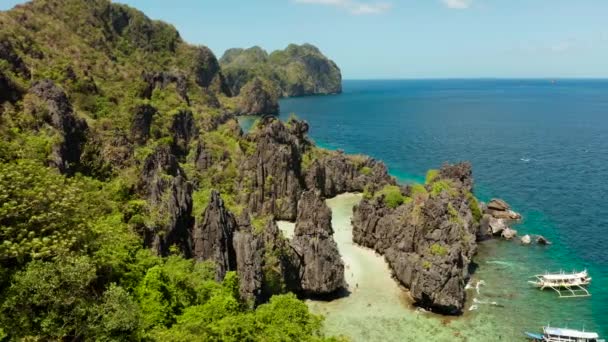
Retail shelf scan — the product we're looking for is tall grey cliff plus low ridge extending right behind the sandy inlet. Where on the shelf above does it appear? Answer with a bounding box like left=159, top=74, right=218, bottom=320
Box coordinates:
left=238, top=117, right=394, bottom=221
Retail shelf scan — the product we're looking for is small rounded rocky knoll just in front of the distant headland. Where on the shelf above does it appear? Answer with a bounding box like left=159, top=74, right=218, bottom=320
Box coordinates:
left=238, top=77, right=279, bottom=115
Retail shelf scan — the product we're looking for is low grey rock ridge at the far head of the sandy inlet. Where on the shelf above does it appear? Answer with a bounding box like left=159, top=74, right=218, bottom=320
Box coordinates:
left=306, top=152, right=395, bottom=197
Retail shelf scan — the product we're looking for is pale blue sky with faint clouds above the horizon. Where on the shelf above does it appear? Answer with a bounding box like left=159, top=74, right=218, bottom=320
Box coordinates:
left=0, top=0, right=608, bottom=79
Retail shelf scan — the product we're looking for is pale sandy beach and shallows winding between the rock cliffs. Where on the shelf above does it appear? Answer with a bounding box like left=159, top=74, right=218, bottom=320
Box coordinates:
left=278, top=194, right=518, bottom=341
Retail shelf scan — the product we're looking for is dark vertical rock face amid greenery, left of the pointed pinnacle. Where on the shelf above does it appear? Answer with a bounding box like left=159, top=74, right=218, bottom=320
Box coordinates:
left=140, top=147, right=194, bottom=257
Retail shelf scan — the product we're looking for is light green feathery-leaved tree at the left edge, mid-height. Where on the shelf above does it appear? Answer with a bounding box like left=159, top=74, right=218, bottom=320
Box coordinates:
left=0, top=160, right=90, bottom=263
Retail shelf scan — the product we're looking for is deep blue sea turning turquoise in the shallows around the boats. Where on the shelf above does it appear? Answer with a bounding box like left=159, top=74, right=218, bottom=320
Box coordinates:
left=280, top=80, right=608, bottom=338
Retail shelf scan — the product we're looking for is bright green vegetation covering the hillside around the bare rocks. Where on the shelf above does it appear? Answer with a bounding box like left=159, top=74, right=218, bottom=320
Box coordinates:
left=0, top=0, right=340, bottom=341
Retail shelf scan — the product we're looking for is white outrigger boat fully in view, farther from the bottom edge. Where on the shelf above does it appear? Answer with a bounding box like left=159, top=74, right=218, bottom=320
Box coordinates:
left=528, top=270, right=591, bottom=298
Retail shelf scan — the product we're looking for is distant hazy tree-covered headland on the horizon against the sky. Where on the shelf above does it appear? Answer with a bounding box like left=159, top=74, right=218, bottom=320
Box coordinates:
left=220, top=44, right=342, bottom=96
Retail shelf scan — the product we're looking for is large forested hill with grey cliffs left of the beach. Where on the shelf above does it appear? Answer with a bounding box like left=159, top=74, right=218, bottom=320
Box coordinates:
left=0, top=0, right=372, bottom=341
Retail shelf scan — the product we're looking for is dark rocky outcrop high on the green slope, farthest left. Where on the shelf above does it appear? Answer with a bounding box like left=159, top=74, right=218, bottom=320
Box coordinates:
left=30, top=80, right=88, bottom=174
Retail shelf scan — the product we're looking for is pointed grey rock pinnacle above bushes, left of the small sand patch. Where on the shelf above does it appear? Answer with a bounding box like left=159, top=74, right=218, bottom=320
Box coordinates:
left=192, top=190, right=236, bottom=280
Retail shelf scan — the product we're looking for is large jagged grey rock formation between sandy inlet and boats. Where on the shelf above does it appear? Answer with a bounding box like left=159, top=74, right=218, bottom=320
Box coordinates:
left=352, top=163, right=479, bottom=314
